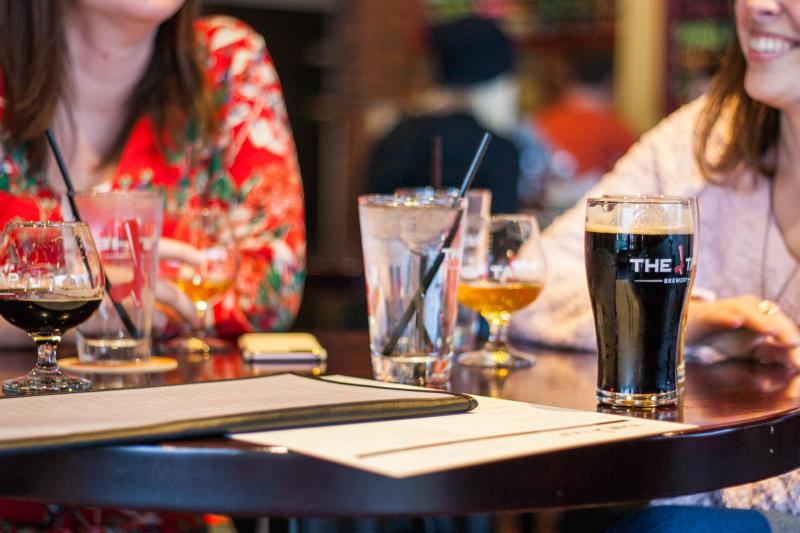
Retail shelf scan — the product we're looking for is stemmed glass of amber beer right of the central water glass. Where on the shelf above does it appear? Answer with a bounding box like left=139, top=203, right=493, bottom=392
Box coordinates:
left=458, top=214, right=546, bottom=368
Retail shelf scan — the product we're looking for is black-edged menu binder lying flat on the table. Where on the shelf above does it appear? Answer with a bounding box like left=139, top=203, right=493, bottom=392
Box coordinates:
left=0, top=374, right=477, bottom=453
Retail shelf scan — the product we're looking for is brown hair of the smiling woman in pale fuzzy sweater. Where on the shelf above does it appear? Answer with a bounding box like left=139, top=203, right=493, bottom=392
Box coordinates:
left=695, top=35, right=780, bottom=182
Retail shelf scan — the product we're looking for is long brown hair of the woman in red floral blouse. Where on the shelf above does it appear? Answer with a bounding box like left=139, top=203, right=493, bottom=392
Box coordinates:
left=0, top=0, right=215, bottom=177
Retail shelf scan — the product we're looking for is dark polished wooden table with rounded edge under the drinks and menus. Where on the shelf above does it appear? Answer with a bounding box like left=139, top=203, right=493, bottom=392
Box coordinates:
left=0, top=331, right=800, bottom=516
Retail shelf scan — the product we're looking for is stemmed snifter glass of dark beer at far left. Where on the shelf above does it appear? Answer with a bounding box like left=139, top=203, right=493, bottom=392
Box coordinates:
left=0, top=218, right=105, bottom=395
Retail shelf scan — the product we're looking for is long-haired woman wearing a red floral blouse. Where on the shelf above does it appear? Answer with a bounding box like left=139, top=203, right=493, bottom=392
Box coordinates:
left=0, top=0, right=305, bottom=344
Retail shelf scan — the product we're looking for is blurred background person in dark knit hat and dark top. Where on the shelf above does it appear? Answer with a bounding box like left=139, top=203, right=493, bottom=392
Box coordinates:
left=367, top=15, right=520, bottom=212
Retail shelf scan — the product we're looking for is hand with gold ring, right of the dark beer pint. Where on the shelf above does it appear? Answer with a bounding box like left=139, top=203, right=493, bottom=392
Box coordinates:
left=686, top=295, right=800, bottom=370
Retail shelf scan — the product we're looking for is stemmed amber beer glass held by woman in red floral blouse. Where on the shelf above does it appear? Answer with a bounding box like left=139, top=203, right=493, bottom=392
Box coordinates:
left=160, top=206, right=239, bottom=353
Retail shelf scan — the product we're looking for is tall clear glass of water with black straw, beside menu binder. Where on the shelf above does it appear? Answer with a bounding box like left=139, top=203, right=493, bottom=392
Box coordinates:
left=358, top=195, right=465, bottom=385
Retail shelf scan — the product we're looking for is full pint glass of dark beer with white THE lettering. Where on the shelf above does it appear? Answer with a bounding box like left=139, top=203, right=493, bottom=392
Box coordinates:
left=585, top=196, right=697, bottom=408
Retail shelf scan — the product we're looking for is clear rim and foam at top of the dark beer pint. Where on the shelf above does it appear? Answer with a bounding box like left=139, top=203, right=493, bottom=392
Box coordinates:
left=586, top=196, right=695, bottom=234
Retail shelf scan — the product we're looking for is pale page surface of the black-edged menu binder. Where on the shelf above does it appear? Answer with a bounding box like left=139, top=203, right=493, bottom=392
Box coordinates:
left=0, top=374, right=456, bottom=444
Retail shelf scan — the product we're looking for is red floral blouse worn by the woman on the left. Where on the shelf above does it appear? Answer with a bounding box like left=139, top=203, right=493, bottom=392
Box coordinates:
left=0, top=16, right=306, bottom=336
